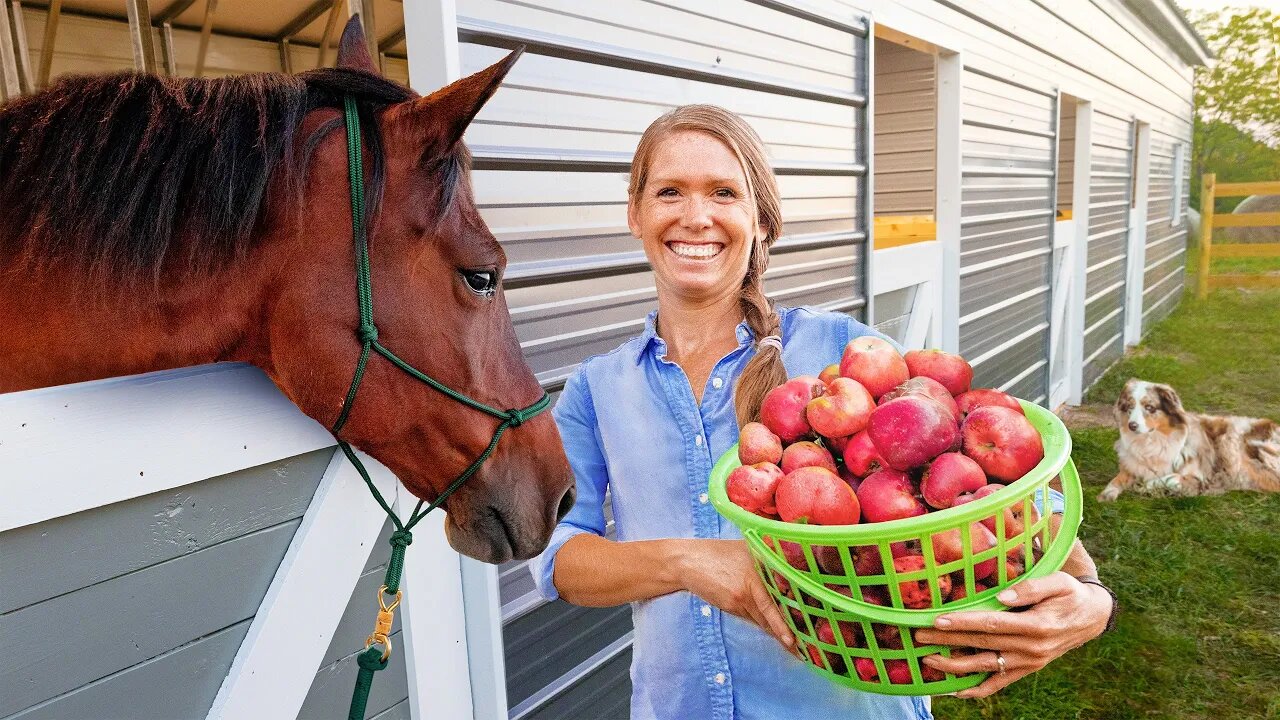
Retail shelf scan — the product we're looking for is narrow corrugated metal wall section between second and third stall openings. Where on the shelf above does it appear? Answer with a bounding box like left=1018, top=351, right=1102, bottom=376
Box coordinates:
left=1084, top=110, right=1134, bottom=387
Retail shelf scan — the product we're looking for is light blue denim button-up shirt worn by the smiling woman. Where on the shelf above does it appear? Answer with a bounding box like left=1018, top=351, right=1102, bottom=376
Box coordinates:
left=530, top=307, right=1059, bottom=720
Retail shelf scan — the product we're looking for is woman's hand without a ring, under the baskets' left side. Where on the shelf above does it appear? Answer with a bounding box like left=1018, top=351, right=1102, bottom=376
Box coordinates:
left=678, top=539, right=796, bottom=653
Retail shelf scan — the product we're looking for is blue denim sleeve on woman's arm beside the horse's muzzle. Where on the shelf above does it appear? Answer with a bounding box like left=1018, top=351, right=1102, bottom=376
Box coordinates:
left=529, top=365, right=609, bottom=600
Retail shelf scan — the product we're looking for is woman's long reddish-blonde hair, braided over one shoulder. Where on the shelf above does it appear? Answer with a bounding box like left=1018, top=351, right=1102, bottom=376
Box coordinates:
left=627, top=105, right=787, bottom=427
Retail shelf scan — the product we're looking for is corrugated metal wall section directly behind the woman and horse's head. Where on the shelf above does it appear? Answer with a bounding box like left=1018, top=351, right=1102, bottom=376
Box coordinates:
left=457, top=0, right=870, bottom=719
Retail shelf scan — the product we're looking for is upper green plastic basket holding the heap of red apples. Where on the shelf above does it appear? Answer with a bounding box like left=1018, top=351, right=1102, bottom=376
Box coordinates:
left=709, top=402, right=1083, bottom=609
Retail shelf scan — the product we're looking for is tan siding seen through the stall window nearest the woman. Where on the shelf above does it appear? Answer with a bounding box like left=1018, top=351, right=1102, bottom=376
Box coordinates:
left=874, top=37, right=938, bottom=215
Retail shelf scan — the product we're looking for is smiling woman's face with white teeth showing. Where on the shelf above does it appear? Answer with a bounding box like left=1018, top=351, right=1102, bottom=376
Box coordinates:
left=627, top=131, right=760, bottom=301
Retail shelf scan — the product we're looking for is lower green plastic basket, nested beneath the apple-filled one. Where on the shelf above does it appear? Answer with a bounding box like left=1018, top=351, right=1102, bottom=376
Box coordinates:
left=746, top=460, right=1080, bottom=696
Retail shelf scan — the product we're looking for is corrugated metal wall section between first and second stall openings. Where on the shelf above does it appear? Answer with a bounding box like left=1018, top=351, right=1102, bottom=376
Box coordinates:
left=960, top=67, right=1057, bottom=404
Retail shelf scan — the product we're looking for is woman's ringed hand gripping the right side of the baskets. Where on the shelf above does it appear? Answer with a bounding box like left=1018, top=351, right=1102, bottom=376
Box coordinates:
left=915, top=571, right=1112, bottom=698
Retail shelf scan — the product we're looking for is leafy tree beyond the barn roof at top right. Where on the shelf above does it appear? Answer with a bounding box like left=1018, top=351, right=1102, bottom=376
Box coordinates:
left=1192, top=8, right=1280, bottom=202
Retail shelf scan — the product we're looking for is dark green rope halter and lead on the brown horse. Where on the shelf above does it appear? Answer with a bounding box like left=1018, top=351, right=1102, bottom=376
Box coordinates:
left=332, top=95, right=550, bottom=720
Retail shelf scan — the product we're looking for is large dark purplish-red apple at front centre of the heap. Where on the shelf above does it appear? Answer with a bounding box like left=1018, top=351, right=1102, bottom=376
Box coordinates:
left=867, top=395, right=957, bottom=470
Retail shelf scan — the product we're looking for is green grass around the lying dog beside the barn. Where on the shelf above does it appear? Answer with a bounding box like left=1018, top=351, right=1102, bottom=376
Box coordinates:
left=933, top=272, right=1280, bottom=720
